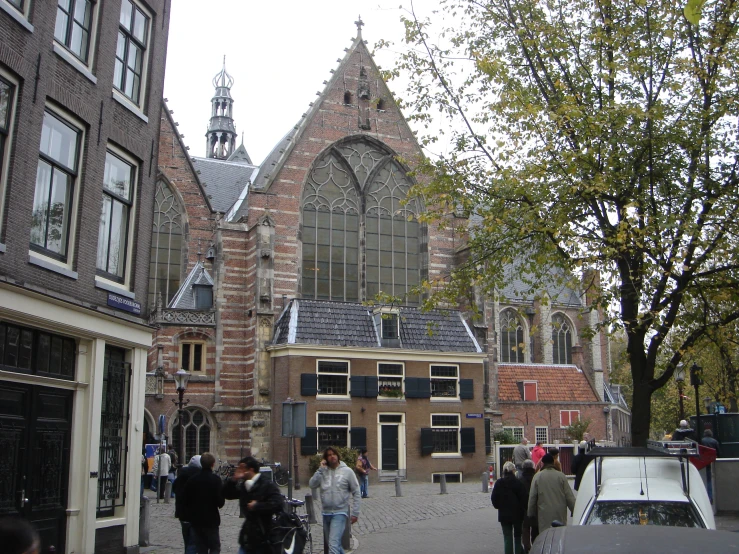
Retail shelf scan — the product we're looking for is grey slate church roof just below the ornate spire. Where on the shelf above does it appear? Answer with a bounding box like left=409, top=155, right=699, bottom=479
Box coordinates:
left=193, top=157, right=258, bottom=213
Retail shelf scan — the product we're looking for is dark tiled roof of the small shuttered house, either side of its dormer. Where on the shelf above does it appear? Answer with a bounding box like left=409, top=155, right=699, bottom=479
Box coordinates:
left=273, top=299, right=482, bottom=352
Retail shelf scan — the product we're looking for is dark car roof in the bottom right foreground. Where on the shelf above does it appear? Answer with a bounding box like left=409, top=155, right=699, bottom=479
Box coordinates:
left=530, top=525, right=739, bottom=554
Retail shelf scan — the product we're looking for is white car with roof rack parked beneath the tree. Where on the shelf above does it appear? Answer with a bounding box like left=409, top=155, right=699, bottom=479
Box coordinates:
left=572, top=442, right=716, bottom=529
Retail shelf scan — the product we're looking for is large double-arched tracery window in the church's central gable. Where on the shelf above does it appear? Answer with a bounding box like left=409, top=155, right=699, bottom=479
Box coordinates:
left=302, top=140, right=421, bottom=304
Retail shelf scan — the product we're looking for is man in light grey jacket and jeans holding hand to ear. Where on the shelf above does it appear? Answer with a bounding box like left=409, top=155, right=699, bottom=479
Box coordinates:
left=308, top=447, right=361, bottom=554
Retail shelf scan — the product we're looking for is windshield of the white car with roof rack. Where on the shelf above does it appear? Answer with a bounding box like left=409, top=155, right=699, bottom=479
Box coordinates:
left=585, top=501, right=704, bottom=527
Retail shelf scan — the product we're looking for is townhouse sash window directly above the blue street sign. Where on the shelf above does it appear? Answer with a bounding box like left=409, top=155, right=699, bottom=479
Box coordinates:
left=97, top=151, right=137, bottom=283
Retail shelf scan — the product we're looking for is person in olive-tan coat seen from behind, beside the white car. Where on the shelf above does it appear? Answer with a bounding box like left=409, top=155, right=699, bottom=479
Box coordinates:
left=528, top=454, right=575, bottom=533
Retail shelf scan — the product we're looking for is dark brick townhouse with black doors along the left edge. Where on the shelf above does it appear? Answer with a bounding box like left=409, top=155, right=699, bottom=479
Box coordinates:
left=0, top=0, right=169, bottom=554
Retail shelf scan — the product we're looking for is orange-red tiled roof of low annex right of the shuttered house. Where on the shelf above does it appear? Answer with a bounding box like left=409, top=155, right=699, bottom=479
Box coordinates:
left=498, top=363, right=601, bottom=402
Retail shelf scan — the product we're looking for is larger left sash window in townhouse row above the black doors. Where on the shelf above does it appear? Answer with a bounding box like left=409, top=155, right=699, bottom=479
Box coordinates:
left=31, top=110, right=83, bottom=262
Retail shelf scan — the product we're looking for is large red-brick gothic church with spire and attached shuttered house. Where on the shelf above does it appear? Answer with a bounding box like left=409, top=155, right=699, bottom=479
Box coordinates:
left=144, top=21, right=626, bottom=483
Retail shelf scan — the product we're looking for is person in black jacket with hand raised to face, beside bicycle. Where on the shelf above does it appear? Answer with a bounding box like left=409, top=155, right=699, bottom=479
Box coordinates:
left=223, top=456, right=284, bottom=554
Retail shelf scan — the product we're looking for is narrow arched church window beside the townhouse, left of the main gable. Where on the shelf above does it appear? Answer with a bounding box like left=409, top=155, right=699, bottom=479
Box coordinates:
left=149, top=180, right=183, bottom=306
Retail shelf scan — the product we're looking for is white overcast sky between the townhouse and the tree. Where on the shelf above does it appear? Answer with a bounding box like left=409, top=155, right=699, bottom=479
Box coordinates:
left=164, top=0, right=438, bottom=164
